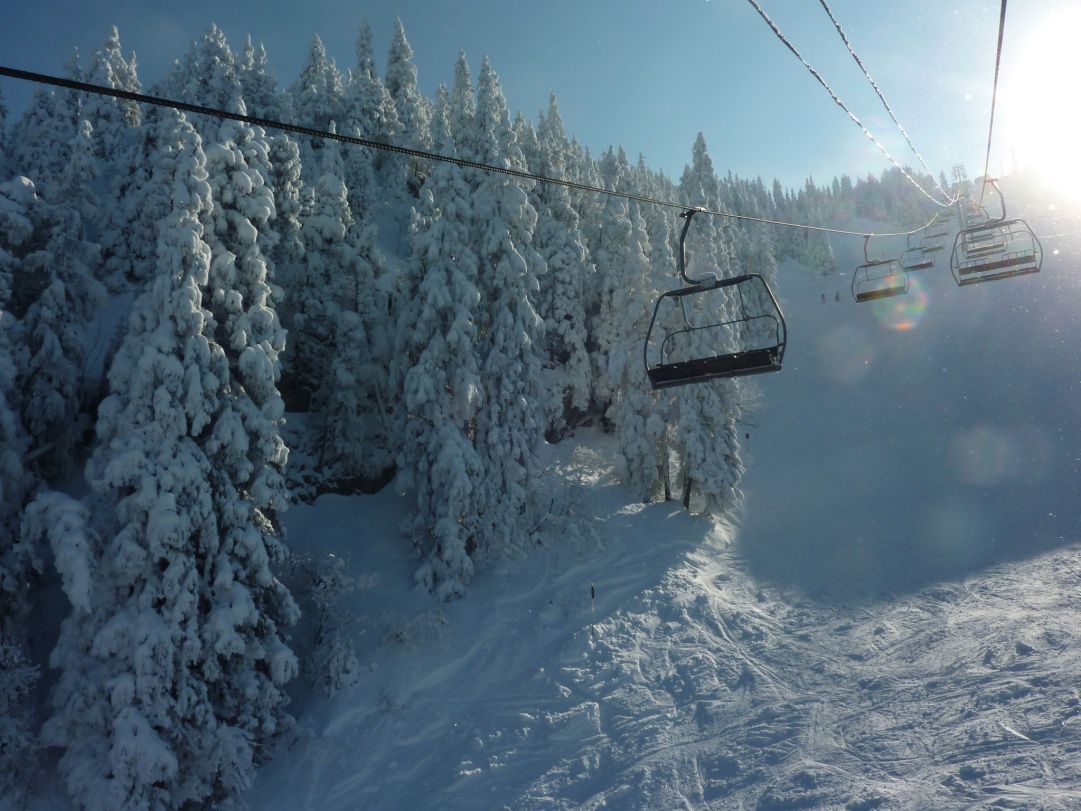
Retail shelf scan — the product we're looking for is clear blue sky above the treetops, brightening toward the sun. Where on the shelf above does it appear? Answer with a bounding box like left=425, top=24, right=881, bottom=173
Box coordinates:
left=0, top=0, right=1081, bottom=195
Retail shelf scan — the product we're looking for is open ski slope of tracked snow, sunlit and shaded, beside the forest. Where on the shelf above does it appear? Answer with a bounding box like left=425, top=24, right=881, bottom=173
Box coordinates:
left=250, top=223, right=1081, bottom=810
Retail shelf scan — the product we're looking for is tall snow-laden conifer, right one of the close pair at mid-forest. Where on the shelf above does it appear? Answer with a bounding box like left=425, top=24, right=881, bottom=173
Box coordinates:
left=472, top=58, right=545, bottom=554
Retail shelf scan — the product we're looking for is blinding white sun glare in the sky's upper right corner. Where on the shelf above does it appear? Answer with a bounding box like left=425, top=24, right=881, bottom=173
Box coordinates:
left=992, top=5, right=1081, bottom=201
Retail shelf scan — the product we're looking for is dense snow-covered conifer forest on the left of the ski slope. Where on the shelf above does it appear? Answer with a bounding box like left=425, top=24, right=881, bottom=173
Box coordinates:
left=6, top=17, right=1077, bottom=811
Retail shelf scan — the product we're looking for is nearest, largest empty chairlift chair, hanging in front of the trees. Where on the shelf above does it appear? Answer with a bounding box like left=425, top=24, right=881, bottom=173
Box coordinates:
left=643, top=209, right=788, bottom=388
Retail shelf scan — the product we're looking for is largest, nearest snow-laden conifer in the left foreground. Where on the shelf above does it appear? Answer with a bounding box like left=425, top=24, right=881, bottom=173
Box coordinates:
left=43, top=111, right=296, bottom=810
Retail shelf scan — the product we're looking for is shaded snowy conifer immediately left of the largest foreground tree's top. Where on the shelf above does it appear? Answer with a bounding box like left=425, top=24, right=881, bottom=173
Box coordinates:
left=18, top=121, right=105, bottom=479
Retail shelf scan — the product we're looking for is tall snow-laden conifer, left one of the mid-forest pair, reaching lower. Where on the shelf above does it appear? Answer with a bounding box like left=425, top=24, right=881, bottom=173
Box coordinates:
left=396, top=88, right=483, bottom=599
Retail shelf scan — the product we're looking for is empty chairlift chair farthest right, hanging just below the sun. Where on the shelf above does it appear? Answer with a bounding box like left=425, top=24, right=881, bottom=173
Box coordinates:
left=950, top=180, right=1043, bottom=287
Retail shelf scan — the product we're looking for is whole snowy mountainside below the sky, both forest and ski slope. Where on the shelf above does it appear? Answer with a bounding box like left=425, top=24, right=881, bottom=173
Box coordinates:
left=0, top=19, right=1081, bottom=811
